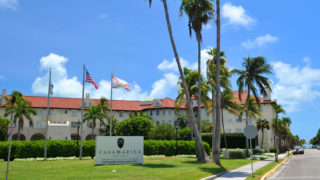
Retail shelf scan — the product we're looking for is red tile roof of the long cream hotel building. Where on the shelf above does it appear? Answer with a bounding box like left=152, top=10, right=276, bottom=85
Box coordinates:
left=0, top=91, right=275, bottom=111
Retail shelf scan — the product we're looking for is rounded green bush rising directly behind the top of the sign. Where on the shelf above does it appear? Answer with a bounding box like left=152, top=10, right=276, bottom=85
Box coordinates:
left=116, top=116, right=153, bottom=137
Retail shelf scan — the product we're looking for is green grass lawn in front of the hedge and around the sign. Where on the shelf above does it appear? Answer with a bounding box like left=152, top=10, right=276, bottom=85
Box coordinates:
left=0, top=157, right=250, bottom=180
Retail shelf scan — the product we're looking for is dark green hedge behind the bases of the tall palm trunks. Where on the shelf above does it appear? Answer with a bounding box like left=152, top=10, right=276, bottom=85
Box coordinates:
left=202, top=133, right=256, bottom=149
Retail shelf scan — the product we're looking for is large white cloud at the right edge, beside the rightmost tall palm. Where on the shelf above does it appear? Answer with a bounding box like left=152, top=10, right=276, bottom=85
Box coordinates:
left=272, top=61, right=320, bottom=112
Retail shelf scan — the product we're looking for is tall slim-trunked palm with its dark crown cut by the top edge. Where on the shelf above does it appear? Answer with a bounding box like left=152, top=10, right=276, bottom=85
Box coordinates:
left=180, top=0, right=214, bottom=132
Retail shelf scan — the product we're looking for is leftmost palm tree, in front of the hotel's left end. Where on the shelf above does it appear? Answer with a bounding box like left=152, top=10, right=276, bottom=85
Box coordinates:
left=4, top=95, right=37, bottom=140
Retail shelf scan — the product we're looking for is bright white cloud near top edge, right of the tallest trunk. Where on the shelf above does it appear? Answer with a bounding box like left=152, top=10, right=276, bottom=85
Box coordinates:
left=222, top=2, right=255, bottom=28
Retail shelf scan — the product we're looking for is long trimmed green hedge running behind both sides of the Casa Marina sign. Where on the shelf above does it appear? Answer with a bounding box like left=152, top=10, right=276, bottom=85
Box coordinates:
left=0, top=140, right=210, bottom=160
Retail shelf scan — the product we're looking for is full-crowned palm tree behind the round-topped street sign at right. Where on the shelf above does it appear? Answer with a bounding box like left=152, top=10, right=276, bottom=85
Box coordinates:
left=232, top=56, right=271, bottom=155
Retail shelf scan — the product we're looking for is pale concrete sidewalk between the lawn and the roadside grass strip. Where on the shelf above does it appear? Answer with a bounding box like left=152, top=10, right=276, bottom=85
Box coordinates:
left=204, top=153, right=287, bottom=180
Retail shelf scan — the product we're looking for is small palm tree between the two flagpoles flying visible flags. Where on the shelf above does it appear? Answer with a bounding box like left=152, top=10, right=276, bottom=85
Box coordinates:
left=83, top=104, right=103, bottom=139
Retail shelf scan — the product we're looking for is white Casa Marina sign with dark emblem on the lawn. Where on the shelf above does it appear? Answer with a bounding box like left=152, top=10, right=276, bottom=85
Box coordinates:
left=95, top=136, right=143, bottom=165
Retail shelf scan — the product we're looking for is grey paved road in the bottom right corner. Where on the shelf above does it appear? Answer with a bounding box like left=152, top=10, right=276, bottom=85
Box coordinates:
left=268, top=149, right=320, bottom=180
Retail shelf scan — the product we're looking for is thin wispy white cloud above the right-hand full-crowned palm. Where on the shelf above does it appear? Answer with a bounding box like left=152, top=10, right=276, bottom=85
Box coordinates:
left=241, top=34, right=278, bottom=49
